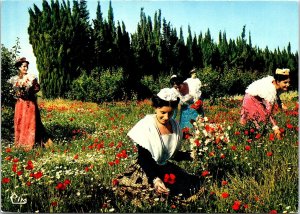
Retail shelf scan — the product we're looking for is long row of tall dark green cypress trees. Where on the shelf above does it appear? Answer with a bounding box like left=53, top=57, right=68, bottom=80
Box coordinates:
left=28, top=0, right=298, bottom=101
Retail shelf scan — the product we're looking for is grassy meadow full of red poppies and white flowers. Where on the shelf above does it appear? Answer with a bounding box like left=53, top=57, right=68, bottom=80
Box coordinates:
left=1, top=92, right=299, bottom=213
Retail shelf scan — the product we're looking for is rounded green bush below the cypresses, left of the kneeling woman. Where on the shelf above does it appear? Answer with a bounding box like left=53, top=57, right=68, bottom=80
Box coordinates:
left=68, top=69, right=125, bottom=102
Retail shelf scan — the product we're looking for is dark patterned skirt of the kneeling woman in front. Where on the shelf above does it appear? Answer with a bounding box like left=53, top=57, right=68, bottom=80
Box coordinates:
left=113, top=161, right=204, bottom=206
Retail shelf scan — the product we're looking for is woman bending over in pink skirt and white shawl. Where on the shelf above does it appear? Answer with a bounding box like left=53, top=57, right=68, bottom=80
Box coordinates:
left=240, top=69, right=290, bottom=137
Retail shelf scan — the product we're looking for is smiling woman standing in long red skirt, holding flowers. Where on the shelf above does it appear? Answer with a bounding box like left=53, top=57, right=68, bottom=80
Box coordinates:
left=8, top=57, right=52, bottom=151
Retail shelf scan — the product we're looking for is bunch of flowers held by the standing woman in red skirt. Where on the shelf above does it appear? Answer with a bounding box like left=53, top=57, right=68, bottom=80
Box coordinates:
left=7, top=74, right=36, bottom=98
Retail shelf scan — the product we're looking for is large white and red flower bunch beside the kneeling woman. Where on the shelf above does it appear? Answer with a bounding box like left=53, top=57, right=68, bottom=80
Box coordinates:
left=189, top=116, right=230, bottom=167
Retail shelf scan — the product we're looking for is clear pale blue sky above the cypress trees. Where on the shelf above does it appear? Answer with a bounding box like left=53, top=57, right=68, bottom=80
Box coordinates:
left=0, top=0, right=299, bottom=74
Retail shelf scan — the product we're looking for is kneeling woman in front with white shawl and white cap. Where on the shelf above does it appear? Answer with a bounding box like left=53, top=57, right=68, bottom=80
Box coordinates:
left=118, top=88, right=201, bottom=198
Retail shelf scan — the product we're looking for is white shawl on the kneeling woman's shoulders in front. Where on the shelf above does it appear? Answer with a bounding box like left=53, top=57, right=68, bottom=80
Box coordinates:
left=127, top=114, right=182, bottom=165
